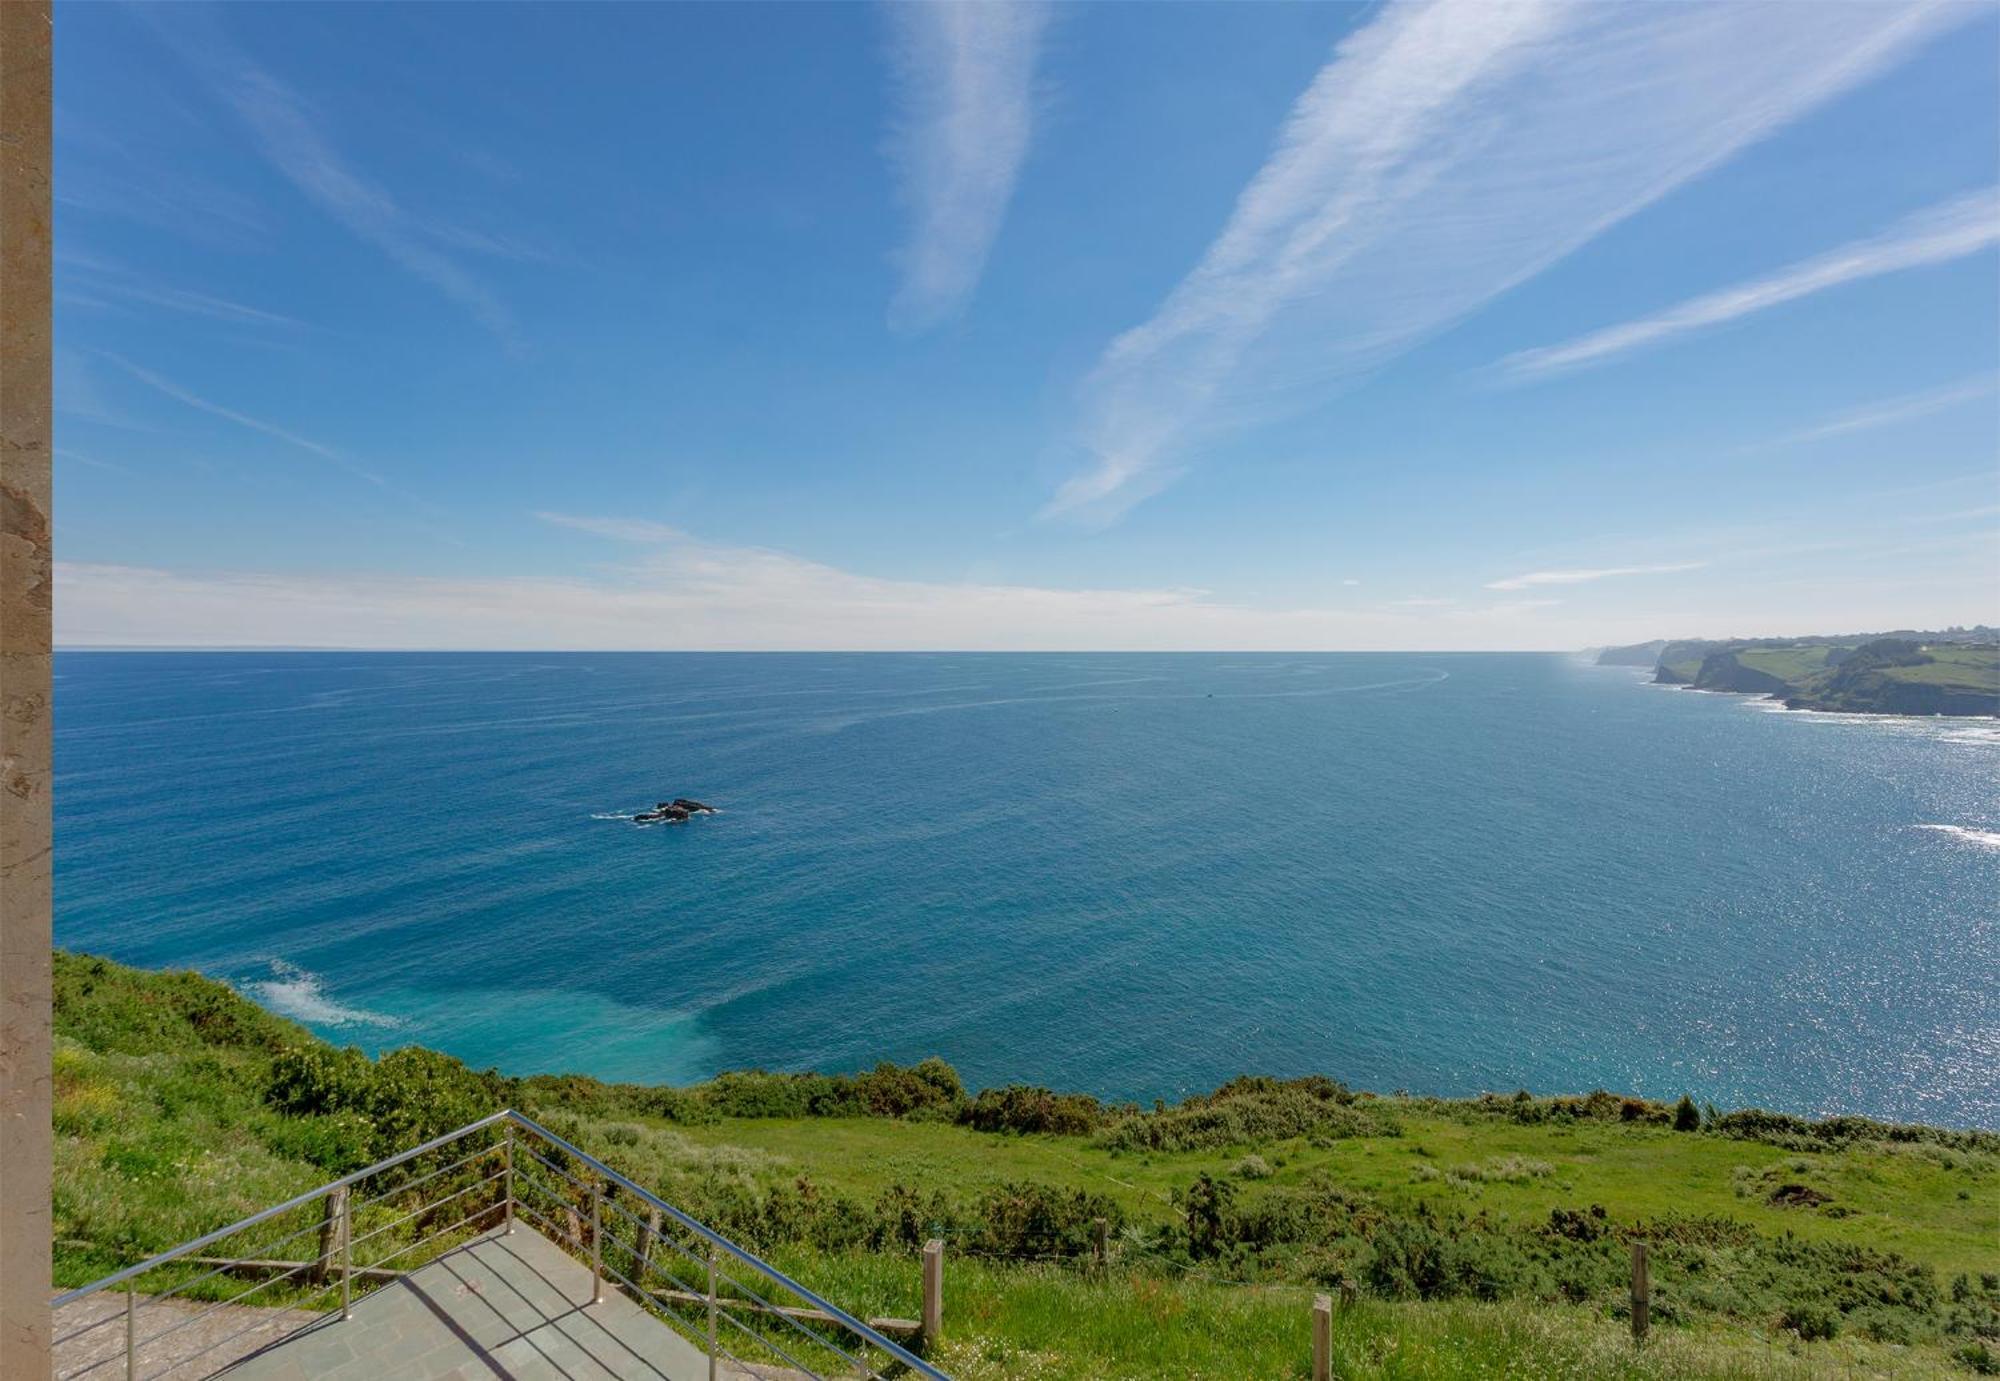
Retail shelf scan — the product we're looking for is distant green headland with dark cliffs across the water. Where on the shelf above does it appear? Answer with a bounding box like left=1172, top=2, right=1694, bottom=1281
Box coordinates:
left=1596, top=628, right=2000, bottom=715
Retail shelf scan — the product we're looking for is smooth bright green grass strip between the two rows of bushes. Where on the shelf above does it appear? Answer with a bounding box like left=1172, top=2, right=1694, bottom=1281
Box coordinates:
left=660, top=1099, right=2000, bottom=1275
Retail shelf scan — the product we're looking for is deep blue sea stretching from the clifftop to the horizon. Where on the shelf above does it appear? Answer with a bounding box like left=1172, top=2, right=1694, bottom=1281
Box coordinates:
left=56, top=652, right=2000, bottom=1127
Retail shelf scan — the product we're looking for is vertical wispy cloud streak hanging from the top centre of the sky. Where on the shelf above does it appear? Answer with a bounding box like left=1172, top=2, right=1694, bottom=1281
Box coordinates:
left=886, top=0, right=1050, bottom=330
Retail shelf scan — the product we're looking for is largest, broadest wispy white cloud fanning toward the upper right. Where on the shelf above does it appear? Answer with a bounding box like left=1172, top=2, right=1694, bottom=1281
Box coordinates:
left=1044, top=0, right=1970, bottom=516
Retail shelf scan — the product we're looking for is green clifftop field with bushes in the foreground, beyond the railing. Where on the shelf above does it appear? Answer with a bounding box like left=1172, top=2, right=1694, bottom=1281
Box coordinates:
left=54, top=953, right=2000, bottom=1379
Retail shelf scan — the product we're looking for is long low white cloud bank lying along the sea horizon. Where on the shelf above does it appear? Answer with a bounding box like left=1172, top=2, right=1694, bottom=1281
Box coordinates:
left=56, top=514, right=1588, bottom=650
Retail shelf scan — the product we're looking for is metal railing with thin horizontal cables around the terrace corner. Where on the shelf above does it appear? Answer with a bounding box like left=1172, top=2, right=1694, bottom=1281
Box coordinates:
left=52, top=1109, right=950, bottom=1381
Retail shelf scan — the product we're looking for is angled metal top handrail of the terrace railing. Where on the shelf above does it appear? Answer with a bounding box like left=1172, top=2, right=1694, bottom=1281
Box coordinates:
left=50, top=1109, right=952, bottom=1381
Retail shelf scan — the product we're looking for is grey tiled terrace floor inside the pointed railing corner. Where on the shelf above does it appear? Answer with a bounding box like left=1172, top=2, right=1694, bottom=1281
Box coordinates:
left=228, top=1225, right=712, bottom=1381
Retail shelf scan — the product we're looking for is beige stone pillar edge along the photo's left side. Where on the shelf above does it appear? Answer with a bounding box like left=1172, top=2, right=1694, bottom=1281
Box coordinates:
left=0, top=0, right=52, bottom=1381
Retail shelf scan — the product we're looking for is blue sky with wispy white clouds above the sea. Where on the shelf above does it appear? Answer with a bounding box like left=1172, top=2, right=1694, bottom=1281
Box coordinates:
left=56, top=0, right=2000, bottom=650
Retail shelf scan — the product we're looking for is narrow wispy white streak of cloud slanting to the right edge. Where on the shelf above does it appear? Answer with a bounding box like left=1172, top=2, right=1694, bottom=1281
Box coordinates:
left=1496, top=188, right=2000, bottom=382
